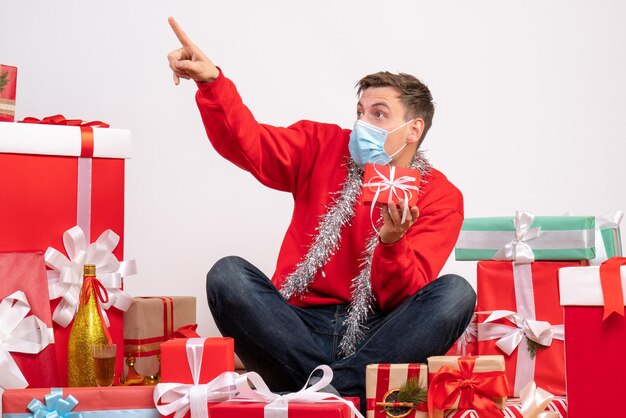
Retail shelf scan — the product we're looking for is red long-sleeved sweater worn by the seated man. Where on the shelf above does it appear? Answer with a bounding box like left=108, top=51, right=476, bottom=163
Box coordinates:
left=196, top=70, right=463, bottom=311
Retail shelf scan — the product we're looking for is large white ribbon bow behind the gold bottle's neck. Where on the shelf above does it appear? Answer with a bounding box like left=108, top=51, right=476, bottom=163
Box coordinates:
left=45, top=226, right=137, bottom=327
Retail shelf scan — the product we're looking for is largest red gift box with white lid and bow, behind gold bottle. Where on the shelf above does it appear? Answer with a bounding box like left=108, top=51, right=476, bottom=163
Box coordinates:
left=0, top=116, right=133, bottom=385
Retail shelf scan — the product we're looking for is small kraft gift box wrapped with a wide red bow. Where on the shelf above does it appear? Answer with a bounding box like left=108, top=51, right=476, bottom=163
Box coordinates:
left=428, top=356, right=509, bottom=418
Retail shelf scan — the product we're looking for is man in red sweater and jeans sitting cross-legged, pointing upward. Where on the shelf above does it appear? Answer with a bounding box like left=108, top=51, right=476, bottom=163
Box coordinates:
left=168, top=18, right=476, bottom=408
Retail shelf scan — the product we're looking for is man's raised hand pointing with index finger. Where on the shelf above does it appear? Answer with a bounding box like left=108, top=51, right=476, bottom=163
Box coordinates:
left=167, top=17, right=220, bottom=85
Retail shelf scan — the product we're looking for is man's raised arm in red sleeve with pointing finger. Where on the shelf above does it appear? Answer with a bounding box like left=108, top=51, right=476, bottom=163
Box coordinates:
left=168, top=17, right=326, bottom=193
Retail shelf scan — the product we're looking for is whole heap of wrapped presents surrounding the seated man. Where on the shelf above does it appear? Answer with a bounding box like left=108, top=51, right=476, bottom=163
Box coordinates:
left=0, top=62, right=626, bottom=418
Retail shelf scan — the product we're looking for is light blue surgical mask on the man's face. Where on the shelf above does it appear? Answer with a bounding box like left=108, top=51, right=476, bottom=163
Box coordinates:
left=348, top=119, right=415, bottom=168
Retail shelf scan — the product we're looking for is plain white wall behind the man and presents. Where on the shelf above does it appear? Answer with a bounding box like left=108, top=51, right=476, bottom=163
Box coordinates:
left=0, top=0, right=626, bottom=335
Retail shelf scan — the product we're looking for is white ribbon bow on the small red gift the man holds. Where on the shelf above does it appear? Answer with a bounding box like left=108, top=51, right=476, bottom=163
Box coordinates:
left=363, top=164, right=419, bottom=232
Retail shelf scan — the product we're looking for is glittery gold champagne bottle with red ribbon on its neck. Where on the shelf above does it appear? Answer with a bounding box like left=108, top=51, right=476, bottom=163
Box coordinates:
left=67, top=264, right=111, bottom=386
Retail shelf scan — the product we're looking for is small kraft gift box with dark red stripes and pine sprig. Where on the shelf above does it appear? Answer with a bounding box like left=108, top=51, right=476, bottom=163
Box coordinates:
left=365, top=363, right=428, bottom=418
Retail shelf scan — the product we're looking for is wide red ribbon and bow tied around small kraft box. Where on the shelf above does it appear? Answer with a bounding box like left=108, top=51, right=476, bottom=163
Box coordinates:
left=428, top=357, right=509, bottom=418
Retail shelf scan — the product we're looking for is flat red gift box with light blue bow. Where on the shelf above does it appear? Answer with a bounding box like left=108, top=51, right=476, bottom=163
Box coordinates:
left=2, top=386, right=161, bottom=418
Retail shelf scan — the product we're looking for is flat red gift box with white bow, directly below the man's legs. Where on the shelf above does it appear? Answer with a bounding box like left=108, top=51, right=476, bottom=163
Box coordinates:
left=209, top=398, right=359, bottom=418
